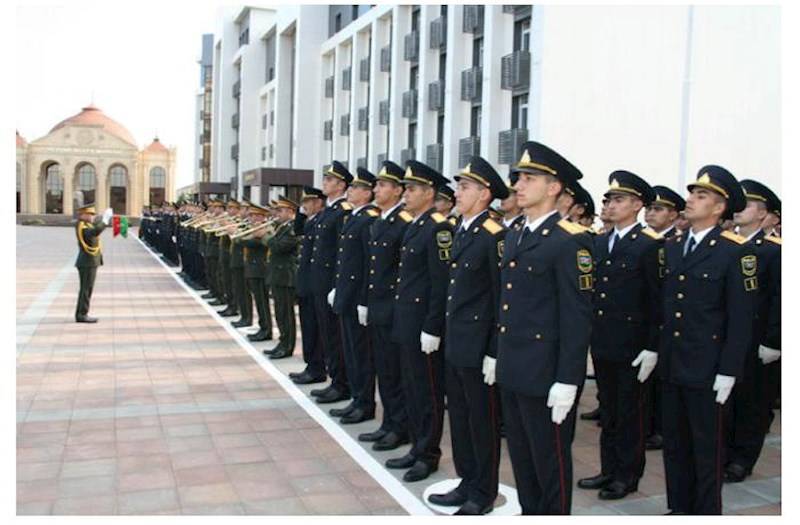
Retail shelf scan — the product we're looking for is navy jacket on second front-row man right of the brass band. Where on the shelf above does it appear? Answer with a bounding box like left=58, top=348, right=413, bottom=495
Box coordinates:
left=304, top=198, right=353, bottom=295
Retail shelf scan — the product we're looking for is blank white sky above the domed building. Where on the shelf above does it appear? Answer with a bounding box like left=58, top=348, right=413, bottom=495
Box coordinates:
left=14, top=0, right=217, bottom=189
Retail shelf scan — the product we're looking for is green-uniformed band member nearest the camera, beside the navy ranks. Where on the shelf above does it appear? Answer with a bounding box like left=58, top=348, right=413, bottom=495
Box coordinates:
left=264, top=197, right=299, bottom=359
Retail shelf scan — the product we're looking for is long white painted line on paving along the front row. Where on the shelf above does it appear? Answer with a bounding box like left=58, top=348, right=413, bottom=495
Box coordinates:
left=135, top=237, right=434, bottom=516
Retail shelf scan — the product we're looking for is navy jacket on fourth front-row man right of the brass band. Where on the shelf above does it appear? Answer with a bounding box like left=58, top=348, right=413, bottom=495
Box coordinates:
left=364, top=207, right=414, bottom=325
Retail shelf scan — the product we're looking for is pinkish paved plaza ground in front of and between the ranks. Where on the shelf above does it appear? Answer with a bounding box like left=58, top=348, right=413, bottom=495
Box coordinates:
left=16, top=226, right=781, bottom=515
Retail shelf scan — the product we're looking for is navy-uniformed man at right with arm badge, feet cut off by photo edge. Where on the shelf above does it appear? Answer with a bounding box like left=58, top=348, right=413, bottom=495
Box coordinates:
left=658, top=165, right=759, bottom=514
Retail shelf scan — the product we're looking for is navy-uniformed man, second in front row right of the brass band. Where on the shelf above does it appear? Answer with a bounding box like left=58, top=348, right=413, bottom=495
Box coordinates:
left=310, top=160, right=353, bottom=403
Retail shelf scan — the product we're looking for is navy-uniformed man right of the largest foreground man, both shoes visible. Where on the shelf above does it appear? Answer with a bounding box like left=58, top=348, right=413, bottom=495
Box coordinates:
left=578, top=170, right=664, bottom=500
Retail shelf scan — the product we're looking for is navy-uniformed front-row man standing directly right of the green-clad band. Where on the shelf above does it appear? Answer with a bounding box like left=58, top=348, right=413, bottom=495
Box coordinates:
left=289, top=186, right=327, bottom=385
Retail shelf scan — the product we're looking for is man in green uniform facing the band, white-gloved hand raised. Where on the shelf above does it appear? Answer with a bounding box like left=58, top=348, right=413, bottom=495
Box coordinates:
left=75, top=204, right=113, bottom=323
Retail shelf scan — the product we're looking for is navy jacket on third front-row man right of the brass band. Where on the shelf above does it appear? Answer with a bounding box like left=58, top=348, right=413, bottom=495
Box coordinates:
left=333, top=204, right=380, bottom=315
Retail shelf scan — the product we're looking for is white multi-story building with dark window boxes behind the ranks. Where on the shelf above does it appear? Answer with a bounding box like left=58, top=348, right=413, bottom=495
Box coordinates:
left=200, top=5, right=780, bottom=202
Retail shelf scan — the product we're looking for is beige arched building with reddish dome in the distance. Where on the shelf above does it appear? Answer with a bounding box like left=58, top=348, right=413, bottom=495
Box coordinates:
left=17, top=105, right=176, bottom=216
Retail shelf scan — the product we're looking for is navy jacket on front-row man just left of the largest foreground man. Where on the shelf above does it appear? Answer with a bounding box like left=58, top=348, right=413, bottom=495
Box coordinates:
left=445, top=211, right=506, bottom=368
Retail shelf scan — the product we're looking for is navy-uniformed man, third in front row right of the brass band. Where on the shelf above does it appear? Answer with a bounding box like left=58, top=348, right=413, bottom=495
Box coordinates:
left=330, top=170, right=380, bottom=425
